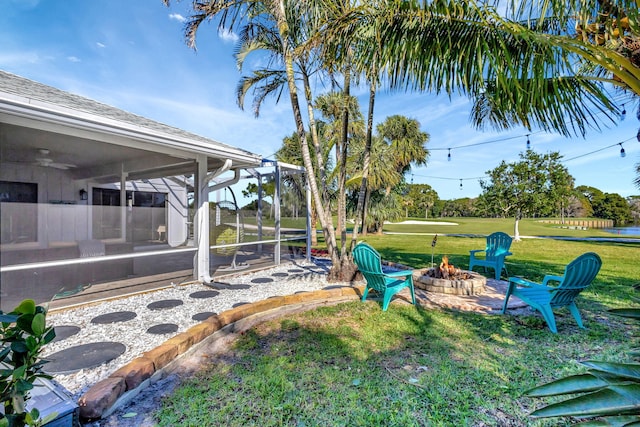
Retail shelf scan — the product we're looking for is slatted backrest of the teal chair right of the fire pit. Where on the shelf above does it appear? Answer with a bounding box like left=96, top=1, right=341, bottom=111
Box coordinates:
left=551, top=252, right=602, bottom=307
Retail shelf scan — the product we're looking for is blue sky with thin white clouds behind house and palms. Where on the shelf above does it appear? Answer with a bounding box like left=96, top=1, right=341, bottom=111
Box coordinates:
left=0, top=0, right=640, bottom=199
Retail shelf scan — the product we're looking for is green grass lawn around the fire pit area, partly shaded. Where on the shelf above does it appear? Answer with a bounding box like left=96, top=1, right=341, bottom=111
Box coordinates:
left=156, top=220, right=640, bottom=426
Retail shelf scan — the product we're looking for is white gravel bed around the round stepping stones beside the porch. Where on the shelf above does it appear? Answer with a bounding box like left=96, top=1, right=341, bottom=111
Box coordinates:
left=43, top=261, right=347, bottom=400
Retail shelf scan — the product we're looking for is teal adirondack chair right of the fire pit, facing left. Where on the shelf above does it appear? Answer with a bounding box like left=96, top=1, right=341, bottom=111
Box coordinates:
left=502, top=252, right=602, bottom=334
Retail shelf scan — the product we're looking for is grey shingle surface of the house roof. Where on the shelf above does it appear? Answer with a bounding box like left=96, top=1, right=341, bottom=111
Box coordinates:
left=0, top=70, right=259, bottom=161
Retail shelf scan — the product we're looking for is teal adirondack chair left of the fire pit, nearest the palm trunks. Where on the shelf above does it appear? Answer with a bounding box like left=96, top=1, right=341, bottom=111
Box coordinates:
left=353, top=242, right=416, bottom=311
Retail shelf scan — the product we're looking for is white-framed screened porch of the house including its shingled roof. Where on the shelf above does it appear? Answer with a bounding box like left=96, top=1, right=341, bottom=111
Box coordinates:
left=0, top=71, right=310, bottom=311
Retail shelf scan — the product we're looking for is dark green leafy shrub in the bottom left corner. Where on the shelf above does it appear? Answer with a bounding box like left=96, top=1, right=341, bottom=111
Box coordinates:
left=0, top=299, right=57, bottom=427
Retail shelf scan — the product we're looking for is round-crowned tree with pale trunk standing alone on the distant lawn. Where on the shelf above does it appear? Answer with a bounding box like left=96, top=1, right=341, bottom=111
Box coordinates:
left=480, top=150, right=573, bottom=241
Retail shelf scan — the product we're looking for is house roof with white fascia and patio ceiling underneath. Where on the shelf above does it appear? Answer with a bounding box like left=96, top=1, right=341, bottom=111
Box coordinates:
left=0, top=71, right=262, bottom=182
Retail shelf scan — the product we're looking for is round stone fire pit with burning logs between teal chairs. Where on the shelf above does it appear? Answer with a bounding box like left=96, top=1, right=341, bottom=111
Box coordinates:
left=413, top=256, right=487, bottom=295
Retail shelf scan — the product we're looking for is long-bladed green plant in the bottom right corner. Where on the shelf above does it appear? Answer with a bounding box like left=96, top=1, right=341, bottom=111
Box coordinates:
left=526, top=284, right=640, bottom=426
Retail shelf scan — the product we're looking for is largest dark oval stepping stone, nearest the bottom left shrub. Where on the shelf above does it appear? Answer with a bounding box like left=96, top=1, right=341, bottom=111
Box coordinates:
left=43, top=341, right=127, bottom=374
